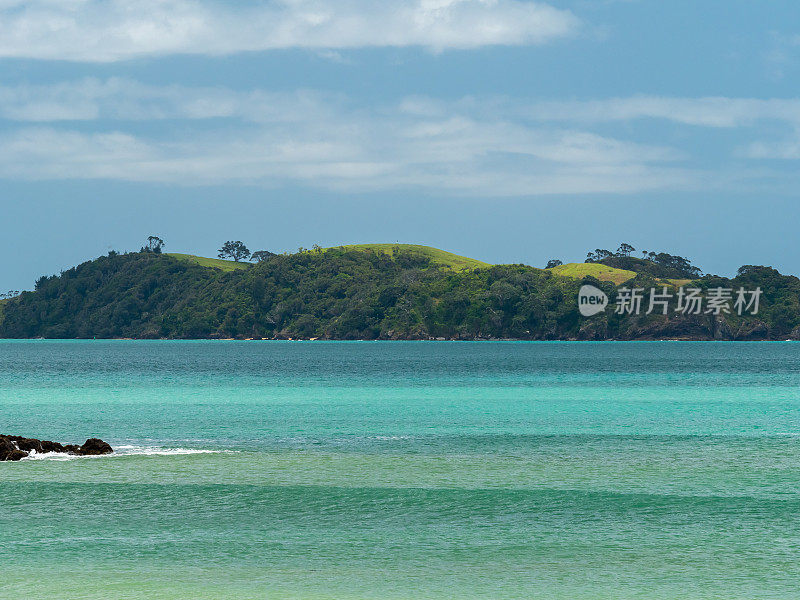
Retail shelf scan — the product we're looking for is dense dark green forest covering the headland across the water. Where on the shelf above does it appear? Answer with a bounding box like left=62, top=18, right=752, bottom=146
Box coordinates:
left=0, top=247, right=800, bottom=340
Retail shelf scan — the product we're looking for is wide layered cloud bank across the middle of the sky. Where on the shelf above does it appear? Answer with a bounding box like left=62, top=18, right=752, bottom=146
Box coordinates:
left=0, top=78, right=800, bottom=197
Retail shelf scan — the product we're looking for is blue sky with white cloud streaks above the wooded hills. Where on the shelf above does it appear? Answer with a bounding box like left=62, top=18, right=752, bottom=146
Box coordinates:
left=0, top=0, right=800, bottom=291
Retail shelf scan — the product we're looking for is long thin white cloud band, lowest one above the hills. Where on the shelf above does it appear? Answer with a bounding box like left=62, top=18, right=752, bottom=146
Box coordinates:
left=0, top=119, right=687, bottom=196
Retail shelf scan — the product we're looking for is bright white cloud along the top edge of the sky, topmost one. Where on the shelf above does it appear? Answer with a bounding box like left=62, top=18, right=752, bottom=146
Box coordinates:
left=0, top=0, right=579, bottom=62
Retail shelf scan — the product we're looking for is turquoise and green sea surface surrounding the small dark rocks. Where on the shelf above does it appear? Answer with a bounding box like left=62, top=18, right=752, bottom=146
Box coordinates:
left=0, top=341, right=800, bottom=600
